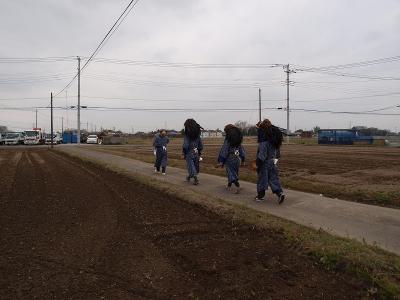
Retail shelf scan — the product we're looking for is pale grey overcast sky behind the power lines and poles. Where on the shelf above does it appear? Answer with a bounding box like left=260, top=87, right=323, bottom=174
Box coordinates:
left=0, top=0, right=400, bottom=132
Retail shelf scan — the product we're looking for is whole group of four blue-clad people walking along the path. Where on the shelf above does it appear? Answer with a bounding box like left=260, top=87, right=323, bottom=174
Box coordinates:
left=153, top=119, right=285, bottom=204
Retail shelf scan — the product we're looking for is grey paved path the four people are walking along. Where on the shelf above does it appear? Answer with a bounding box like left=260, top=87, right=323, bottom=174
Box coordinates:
left=57, top=146, right=400, bottom=254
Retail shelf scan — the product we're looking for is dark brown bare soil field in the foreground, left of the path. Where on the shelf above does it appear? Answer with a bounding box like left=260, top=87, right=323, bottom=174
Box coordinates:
left=0, top=148, right=367, bottom=299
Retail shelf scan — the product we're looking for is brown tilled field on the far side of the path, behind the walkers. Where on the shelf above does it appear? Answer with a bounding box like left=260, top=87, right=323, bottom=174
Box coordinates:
left=93, top=139, right=400, bottom=207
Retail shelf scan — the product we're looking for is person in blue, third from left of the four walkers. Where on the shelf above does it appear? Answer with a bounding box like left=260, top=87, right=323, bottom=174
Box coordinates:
left=218, top=124, right=245, bottom=194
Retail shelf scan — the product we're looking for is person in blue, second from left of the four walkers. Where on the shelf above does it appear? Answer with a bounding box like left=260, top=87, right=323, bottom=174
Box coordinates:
left=182, top=119, right=203, bottom=185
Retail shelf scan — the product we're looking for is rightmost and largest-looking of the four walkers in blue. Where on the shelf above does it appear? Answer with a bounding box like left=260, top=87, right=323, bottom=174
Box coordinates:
left=255, top=119, right=285, bottom=204
